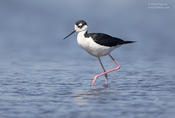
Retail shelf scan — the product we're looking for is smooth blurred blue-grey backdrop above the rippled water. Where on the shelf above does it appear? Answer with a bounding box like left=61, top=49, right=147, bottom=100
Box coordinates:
left=0, top=0, right=175, bottom=60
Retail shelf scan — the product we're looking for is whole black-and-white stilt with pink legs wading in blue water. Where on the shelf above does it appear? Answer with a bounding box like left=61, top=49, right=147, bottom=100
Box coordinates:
left=64, top=20, right=135, bottom=85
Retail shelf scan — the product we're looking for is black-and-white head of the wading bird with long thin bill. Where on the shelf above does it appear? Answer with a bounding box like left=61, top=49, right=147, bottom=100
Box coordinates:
left=64, top=20, right=88, bottom=39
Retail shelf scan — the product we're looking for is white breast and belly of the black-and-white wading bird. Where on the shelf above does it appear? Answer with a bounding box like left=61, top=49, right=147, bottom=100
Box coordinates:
left=77, top=32, right=116, bottom=57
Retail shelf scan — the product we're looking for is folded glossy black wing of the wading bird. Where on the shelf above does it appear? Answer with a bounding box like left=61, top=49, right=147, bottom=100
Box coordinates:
left=86, top=33, right=125, bottom=47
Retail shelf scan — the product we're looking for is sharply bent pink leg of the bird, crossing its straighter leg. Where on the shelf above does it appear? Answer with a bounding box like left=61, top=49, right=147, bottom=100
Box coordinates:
left=91, top=54, right=120, bottom=86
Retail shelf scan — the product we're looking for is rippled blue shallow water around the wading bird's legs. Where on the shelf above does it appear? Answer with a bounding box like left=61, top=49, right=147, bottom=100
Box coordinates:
left=0, top=53, right=175, bottom=118
